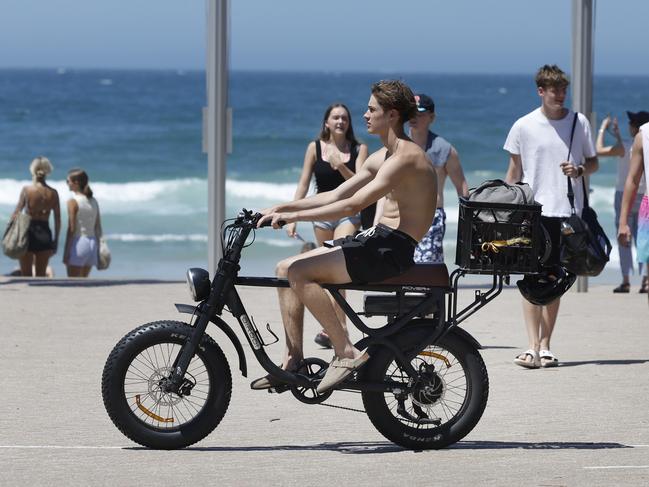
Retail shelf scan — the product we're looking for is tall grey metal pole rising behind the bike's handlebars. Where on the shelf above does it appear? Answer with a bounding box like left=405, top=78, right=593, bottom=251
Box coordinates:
left=204, top=0, right=229, bottom=273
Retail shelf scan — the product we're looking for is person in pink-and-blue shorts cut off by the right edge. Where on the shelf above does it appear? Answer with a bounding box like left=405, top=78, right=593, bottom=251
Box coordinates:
left=617, top=123, right=649, bottom=304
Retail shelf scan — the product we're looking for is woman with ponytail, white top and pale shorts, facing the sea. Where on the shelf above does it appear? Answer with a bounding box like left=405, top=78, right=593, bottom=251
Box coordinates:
left=63, top=169, right=102, bottom=277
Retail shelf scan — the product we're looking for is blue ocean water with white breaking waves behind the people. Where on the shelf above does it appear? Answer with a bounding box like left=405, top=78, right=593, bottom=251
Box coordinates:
left=0, top=69, right=649, bottom=283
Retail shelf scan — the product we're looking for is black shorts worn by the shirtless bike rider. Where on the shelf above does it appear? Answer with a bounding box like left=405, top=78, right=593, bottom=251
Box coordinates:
left=325, top=223, right=417, bottom=284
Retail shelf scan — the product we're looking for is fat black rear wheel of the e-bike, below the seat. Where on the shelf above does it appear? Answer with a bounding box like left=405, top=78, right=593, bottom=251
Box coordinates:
left=362, top=333, right=489, bottom=450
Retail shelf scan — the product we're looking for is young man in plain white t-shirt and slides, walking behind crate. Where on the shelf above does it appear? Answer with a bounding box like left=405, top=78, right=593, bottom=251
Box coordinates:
left=503, top=64, right=599, bottom=368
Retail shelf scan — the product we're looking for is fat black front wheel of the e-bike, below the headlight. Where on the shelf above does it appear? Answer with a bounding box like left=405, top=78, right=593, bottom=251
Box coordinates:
left=102, top=321, right=232, bottom=450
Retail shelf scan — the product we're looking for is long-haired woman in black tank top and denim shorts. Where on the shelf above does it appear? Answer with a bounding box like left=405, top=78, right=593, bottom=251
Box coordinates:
left=286, top=103, right=367, bottom=348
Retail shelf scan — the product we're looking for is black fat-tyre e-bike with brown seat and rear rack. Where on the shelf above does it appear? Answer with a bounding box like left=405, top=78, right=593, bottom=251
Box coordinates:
left=102, top=201, right=536, bottom=449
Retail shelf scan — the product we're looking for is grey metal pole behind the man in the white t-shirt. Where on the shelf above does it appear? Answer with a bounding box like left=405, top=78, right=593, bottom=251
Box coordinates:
left=571, top=0, right=594, bottom=292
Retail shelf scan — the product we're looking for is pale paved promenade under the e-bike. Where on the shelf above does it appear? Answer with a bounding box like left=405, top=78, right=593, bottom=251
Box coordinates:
left=0, top=278, right=649, bottom=487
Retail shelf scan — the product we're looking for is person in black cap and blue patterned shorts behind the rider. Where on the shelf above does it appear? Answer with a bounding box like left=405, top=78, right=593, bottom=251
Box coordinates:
left=410, top=93, right=469, bottom=264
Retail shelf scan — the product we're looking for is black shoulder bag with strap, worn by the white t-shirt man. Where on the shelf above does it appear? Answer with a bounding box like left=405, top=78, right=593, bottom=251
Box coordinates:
left=561, top=113, right=611, bottom=276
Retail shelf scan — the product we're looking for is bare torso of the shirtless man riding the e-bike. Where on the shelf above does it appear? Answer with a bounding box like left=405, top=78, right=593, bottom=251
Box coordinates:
left=377, top=139, right=438, bottom=241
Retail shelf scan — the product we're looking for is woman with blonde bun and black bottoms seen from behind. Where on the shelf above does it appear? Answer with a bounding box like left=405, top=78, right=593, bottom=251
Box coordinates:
left=12, top=156, right=61, bottom=277
